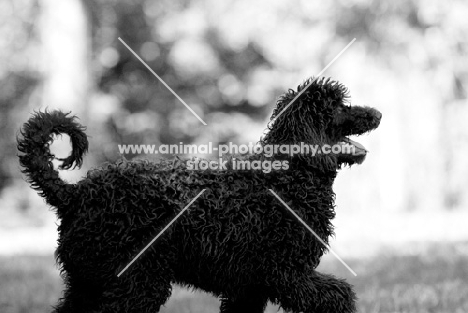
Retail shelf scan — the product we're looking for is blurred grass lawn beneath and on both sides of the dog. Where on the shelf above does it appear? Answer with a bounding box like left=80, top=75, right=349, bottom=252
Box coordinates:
left=0, top=245, right=468, bottom=313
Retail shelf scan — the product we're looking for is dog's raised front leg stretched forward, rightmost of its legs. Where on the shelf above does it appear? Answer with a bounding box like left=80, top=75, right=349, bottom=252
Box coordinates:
left=274, top=271, right=356, bottom=313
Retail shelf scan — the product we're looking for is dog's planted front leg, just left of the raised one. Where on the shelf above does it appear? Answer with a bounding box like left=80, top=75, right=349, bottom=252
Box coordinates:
left=220, top=286, right=268, bottom=313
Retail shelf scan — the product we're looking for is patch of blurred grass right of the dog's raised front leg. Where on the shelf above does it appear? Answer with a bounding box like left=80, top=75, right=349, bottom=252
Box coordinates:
left=321, top=246, right=468, bottom=313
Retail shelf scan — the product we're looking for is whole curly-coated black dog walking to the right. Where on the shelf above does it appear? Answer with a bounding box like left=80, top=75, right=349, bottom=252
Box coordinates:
left=18, top=79, right=381, bottom=313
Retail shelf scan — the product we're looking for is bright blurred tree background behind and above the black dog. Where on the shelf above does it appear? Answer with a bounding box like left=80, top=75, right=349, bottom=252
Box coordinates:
left=0, top=0, right=468, bottom=312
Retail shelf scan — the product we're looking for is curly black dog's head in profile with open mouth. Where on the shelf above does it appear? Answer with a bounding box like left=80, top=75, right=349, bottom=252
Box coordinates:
left=262, top=78, right=382, bottom=168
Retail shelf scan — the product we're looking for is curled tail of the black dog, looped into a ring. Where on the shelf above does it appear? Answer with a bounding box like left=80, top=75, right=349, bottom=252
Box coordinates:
left=17, top=111, right=88, bottom=207
